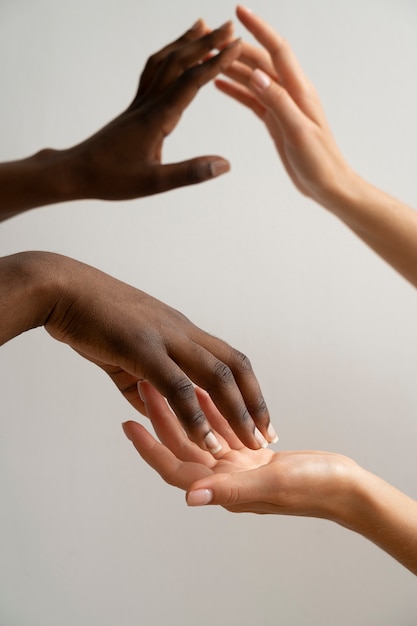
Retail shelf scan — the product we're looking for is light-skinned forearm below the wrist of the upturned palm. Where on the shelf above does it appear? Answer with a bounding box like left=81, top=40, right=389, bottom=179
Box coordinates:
left=334, top=467, right=417, bottom=574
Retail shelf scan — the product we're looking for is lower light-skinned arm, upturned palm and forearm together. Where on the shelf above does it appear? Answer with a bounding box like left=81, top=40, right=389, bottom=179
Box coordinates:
left=123, top=382, right=417, bottom=574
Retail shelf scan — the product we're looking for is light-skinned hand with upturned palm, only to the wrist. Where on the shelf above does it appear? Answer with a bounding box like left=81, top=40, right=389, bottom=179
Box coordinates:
left=123, top=383, right=359, bottom=521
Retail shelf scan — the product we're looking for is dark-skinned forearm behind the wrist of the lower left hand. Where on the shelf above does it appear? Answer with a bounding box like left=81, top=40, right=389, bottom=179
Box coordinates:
left=0, top=252, right=59, bottom=345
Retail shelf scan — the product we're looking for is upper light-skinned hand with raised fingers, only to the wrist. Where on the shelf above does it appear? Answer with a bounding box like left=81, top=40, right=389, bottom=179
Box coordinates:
left=215, top=6, right=354, bottom=208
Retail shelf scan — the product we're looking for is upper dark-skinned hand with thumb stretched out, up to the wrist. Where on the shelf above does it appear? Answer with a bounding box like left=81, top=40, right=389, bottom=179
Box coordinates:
left=69, top=20, right=240, bottom=200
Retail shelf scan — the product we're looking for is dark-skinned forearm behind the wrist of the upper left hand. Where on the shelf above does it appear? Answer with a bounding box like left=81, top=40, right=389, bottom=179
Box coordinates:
left=0, top=149, right=78, bottom=220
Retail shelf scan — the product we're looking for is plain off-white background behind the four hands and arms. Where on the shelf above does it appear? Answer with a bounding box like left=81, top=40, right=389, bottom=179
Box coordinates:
left=0, top=0, right=417, bottom=626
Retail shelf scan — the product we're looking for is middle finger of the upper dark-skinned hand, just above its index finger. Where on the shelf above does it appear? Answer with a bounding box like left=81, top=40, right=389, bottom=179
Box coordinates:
left=141, top=21, right=233, bottom=97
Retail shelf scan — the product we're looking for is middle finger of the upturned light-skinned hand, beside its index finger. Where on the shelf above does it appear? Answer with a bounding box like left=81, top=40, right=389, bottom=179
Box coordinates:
left=138, top=381, right=219, bottom=460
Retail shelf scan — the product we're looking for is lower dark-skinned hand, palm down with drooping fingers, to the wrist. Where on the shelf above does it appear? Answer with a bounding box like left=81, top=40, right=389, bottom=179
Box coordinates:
left=42, top=253, right=275, bottom=451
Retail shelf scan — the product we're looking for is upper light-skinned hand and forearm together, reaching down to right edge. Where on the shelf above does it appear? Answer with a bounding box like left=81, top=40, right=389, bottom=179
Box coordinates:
left=215, top=6, right=417, bottom=286
